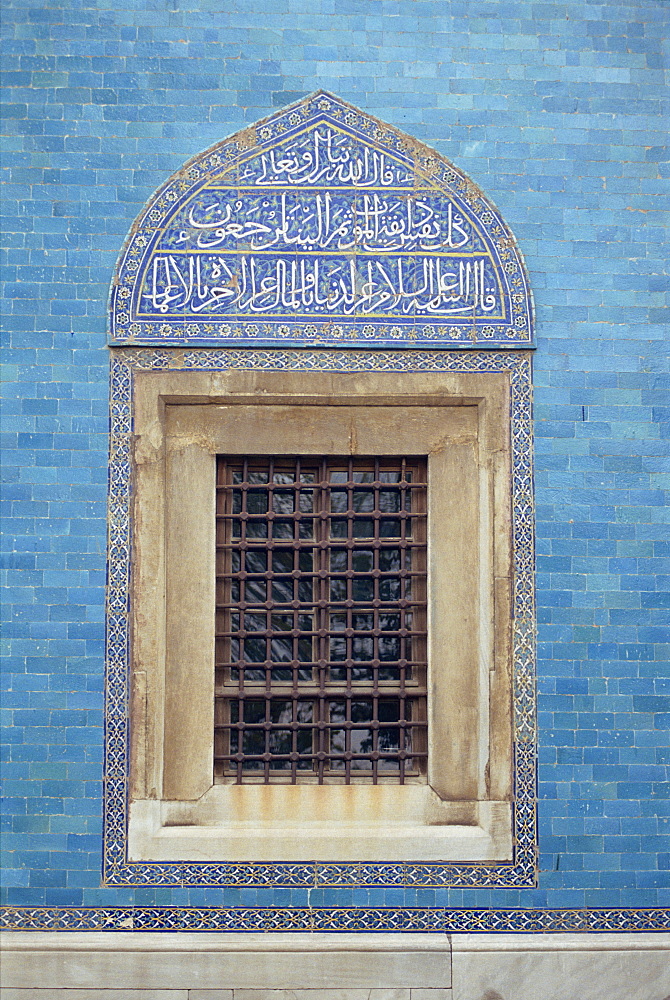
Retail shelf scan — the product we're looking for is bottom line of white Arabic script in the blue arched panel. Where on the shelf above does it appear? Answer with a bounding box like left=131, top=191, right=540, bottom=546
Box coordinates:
left=141, top=253, right=499, bottom=316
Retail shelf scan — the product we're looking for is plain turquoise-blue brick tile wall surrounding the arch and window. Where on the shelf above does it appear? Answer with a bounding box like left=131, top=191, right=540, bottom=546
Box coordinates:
left=1, top=0, right=670, bottom=908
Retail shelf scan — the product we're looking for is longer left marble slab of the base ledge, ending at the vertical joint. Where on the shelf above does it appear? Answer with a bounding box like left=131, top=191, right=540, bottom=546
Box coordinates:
left=0, top=931, right=451, bottom=1000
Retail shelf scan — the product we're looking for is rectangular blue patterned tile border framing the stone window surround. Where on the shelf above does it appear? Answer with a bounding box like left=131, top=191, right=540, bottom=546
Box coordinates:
left=103, top=348, right=537, bottom=889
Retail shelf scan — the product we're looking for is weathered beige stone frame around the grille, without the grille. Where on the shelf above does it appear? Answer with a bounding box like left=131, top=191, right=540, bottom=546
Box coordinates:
left=128, top=370, right=513, bottom=863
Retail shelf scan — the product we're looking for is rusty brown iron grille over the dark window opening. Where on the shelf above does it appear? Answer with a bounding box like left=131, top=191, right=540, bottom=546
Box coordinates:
left=214, top=456, right=427, bottom=784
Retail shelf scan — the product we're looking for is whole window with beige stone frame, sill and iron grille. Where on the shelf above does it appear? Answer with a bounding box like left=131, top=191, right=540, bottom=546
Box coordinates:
left=128, top=371, right=512, bottom=861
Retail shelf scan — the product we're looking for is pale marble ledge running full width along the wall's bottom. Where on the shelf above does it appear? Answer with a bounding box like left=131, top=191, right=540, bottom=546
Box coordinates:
left=0, top=931, right=670, bottom=1000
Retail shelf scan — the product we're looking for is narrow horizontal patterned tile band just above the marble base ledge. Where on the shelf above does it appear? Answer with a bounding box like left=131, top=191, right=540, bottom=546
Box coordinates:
left=0, top=906, right=670, bottom=934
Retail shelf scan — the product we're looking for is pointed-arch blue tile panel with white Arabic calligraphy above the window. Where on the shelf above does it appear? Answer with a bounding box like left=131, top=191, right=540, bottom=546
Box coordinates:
left=110, top=92, right=532, bottom=349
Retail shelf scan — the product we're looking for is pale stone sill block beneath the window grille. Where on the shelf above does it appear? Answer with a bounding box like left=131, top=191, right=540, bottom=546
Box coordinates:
left=129, top=792, right=511, bottom=861
